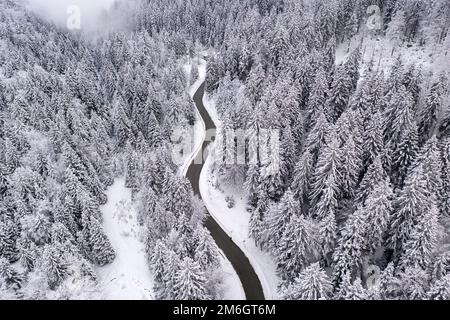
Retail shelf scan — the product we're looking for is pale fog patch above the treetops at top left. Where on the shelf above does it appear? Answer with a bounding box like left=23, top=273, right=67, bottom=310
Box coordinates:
left=26, top=0, right=118, bottom=31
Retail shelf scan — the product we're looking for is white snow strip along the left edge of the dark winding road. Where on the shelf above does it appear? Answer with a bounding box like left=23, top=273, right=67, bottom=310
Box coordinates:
left=179, top=58, right=245, bottom=300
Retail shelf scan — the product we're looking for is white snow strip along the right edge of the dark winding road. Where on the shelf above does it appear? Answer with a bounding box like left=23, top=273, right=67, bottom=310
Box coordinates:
left=200, top=94, right=280, bottom=299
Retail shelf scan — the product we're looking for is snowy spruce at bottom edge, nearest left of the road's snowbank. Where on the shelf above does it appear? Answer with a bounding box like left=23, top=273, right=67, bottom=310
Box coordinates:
left=173, top=257, right=211, bottom=300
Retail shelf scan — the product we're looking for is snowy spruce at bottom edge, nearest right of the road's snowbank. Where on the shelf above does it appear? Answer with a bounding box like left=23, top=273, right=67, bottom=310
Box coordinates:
left=283, top=262, right=333, bottom=300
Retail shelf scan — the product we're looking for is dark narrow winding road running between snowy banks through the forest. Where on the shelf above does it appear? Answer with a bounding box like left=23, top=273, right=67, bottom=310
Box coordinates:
left=186, top=83, right=264, bottom=300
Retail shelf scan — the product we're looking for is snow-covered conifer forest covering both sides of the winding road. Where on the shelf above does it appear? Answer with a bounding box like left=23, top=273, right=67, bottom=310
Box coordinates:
left=0, top=0, right=450, bottom=300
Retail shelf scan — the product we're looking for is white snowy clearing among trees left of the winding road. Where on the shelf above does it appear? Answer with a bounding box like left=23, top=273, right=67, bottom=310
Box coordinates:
left=96, top=178, right=154, bottom=300
